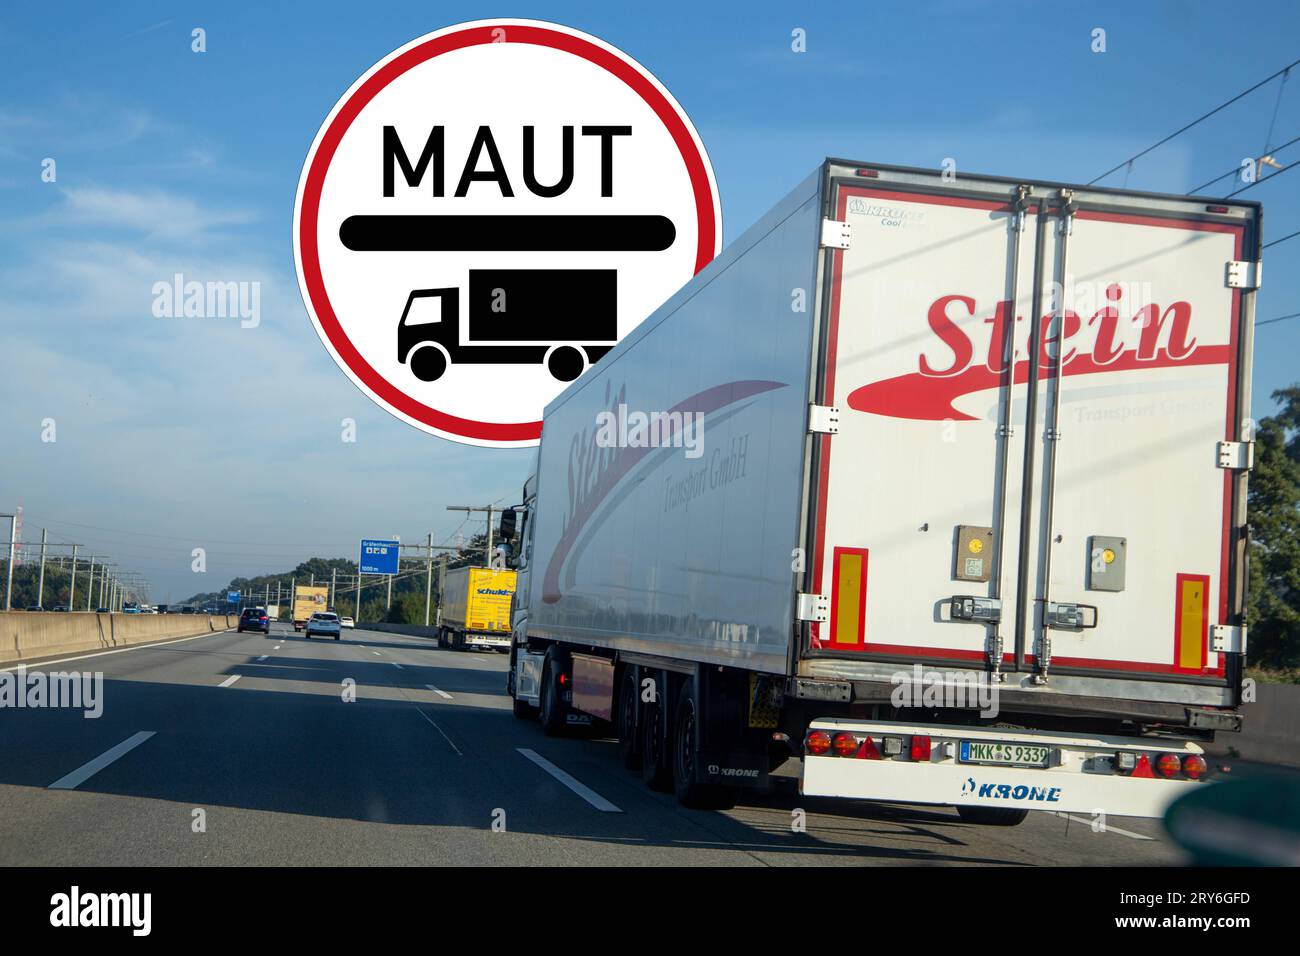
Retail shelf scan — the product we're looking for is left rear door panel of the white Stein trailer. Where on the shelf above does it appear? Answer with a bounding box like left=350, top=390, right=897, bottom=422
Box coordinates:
left=809, top=174, right=1037, bottom=669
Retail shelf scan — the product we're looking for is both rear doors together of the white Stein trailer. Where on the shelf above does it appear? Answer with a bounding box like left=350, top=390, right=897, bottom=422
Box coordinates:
left=806, top=164, right=1258, bottom=702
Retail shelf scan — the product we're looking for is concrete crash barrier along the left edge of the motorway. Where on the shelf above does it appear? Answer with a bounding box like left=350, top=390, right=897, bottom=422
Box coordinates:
left=0, top=611, right=234, bottom=663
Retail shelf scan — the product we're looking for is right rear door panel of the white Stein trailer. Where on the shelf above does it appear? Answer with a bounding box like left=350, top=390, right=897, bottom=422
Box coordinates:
left=1015, top=190, right=1256, bottom=684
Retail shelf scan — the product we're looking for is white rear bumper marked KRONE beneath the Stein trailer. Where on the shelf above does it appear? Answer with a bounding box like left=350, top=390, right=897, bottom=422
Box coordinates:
left=800, top=719, right=1213, bottom=817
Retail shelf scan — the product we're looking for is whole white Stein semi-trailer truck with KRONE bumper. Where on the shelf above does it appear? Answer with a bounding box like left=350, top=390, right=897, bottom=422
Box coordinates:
left=507, top=160, right=1261, bottom=825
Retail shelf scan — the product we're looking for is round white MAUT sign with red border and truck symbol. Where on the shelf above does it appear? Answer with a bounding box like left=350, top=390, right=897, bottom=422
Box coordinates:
left=294, top=20, right=722, bottom=446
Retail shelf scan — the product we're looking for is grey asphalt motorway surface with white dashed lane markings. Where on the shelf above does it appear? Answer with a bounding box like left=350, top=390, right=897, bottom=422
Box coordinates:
left=0, top=624, right=1183, bottom=866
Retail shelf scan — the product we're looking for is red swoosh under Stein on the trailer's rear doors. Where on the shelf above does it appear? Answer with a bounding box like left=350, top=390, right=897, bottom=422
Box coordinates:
left=849, top=345, right=1229, bottom=421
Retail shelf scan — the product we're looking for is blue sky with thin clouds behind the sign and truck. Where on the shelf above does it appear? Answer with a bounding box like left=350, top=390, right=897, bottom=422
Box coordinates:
left=0, top=0, right=1300, bottom=600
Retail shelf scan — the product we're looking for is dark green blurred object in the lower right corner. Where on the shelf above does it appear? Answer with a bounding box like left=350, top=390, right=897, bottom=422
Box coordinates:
left=1165, top=769, right=1300, bottom=866
